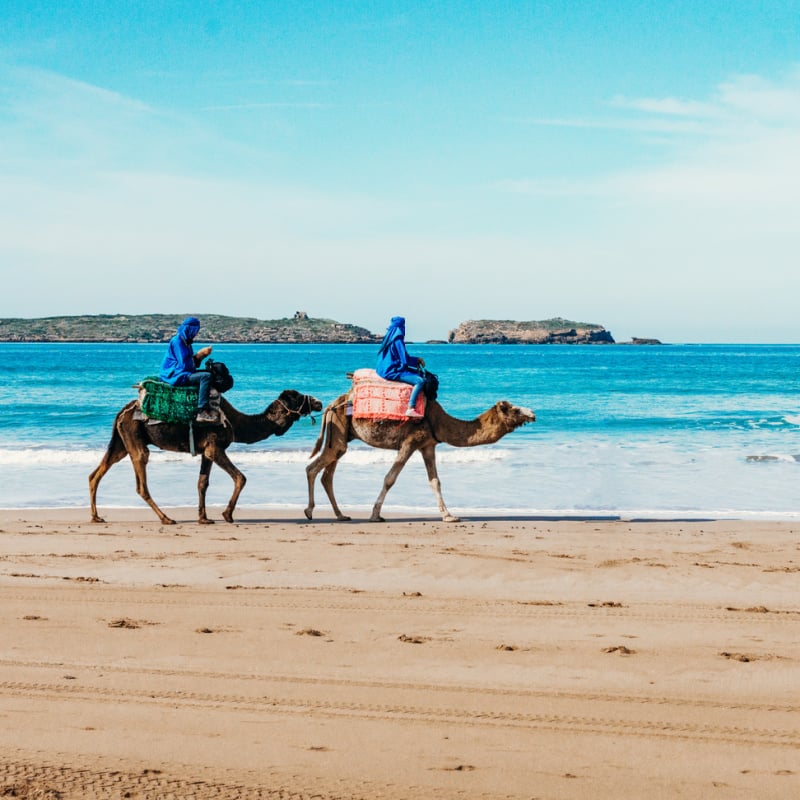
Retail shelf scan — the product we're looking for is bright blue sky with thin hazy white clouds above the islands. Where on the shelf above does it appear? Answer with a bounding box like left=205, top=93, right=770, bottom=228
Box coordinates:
left=0, top=0, right=800, bottom=343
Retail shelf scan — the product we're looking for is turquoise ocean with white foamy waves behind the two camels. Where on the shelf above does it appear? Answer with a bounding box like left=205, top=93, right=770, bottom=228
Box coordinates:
left=0, top=343, right=800, bottom=519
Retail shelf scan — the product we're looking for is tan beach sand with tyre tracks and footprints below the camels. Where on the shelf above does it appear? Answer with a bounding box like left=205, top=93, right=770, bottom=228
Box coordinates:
left=0, top=507, right=800, bottom=800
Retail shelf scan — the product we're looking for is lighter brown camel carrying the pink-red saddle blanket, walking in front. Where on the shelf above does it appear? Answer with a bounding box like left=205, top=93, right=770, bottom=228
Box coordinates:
left=305, top=394, right=536, bottom=522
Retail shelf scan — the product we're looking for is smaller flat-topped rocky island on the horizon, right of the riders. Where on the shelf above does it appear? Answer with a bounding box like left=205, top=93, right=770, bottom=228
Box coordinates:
left=447, top=317, right=615, bottom=344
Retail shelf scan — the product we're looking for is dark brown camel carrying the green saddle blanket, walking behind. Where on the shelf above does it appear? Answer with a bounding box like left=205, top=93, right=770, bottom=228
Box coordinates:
left=89, top=389, right=322, bottom=525
